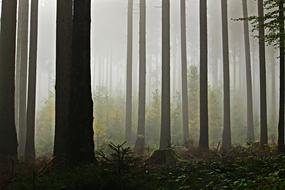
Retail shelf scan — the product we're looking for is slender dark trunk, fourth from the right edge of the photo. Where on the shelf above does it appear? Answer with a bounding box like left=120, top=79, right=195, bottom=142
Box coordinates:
left=221, top=0, right=232, bottom=149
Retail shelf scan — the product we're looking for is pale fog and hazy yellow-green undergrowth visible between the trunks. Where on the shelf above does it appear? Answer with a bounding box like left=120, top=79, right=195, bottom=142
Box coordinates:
left=2, top=0, right=279, bottom=154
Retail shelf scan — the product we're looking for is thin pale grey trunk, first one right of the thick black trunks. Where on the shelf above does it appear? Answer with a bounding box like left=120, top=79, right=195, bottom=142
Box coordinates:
left=126, top=0, right=133, bottom=142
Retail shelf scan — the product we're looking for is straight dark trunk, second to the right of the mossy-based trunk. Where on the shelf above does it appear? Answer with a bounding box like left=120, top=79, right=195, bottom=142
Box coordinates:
left=199, top=0, right=209, bottom=151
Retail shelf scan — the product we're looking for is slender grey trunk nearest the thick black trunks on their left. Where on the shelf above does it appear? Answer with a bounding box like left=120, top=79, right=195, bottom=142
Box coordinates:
left=25, top=0, right=38, bottom=161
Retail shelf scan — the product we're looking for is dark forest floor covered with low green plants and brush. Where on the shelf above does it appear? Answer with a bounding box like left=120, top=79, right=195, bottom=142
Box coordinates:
left=0, top=145, right=285, bottom=190
